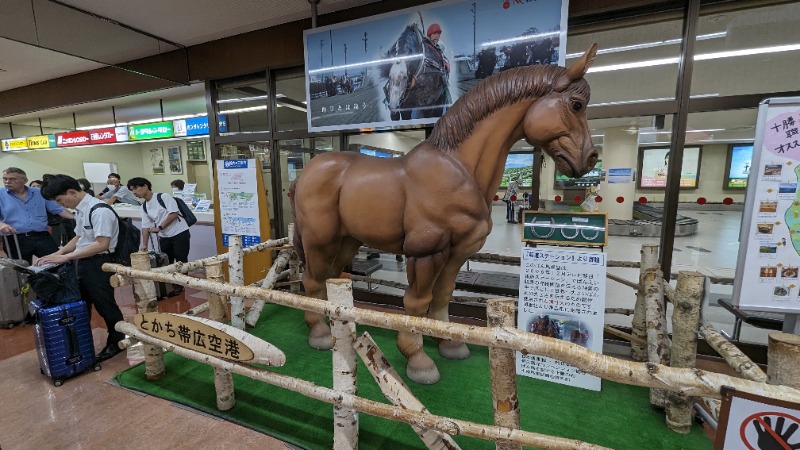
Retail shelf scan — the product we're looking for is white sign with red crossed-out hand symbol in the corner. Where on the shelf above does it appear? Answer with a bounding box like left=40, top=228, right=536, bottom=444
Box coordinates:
left=714, top=392, right=800, bottom=450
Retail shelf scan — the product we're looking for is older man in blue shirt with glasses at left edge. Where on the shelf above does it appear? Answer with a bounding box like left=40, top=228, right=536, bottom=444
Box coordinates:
left=0, top=167, right=75, bottom=263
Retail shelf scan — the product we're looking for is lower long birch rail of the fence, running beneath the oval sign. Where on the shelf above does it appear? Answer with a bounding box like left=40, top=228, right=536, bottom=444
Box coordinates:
left=117, top=322, right=608, bottom=450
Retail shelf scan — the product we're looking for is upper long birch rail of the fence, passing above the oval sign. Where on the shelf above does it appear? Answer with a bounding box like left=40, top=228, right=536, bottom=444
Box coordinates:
left=103, top=263, right=800, bottom=402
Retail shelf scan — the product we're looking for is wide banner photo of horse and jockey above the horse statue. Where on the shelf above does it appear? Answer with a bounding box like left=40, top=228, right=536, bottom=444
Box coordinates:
left=303, top=0, right=567, bottom=132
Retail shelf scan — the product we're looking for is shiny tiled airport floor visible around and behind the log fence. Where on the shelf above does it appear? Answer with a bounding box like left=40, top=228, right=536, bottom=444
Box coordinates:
left=0, top=208, right=752, bottom=450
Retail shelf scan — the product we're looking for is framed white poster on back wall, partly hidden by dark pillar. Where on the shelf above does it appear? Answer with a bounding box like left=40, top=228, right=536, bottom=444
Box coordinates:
left=639, top=147, right=700, bottom=189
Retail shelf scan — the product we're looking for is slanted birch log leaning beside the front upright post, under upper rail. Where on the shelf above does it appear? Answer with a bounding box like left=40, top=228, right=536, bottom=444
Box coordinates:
left=355, top=331, right=460, bottom=450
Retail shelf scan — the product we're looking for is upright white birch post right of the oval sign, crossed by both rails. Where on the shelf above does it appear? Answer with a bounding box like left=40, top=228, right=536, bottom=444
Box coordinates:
left=328, top=280, right=358, bottom=450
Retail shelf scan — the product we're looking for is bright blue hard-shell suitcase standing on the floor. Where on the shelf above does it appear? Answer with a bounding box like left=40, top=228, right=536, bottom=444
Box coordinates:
left=29, top=299, right=100, bottom=386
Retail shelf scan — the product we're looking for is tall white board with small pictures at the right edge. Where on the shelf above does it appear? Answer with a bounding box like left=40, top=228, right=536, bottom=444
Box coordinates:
left=734, top=98, right=800, bottom=313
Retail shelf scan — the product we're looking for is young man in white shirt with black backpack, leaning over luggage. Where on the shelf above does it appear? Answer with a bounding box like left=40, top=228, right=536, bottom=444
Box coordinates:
left=36, top=175, right=126, bottom=362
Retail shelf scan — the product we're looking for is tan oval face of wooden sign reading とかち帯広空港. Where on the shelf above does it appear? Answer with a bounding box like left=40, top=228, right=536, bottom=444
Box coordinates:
left=133, top=313, right=255, bottom=361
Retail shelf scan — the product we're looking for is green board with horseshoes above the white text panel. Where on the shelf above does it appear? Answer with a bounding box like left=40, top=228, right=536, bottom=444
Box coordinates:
left=522, top=211, right=608, bottom=246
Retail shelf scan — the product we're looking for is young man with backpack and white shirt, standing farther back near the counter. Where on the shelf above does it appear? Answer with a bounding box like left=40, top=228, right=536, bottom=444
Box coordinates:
left=128, top=177, right=194, bottom=297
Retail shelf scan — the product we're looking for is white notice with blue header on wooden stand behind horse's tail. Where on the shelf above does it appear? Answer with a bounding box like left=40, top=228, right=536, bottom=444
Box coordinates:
left=217, top=159, right=261, bottom=247
